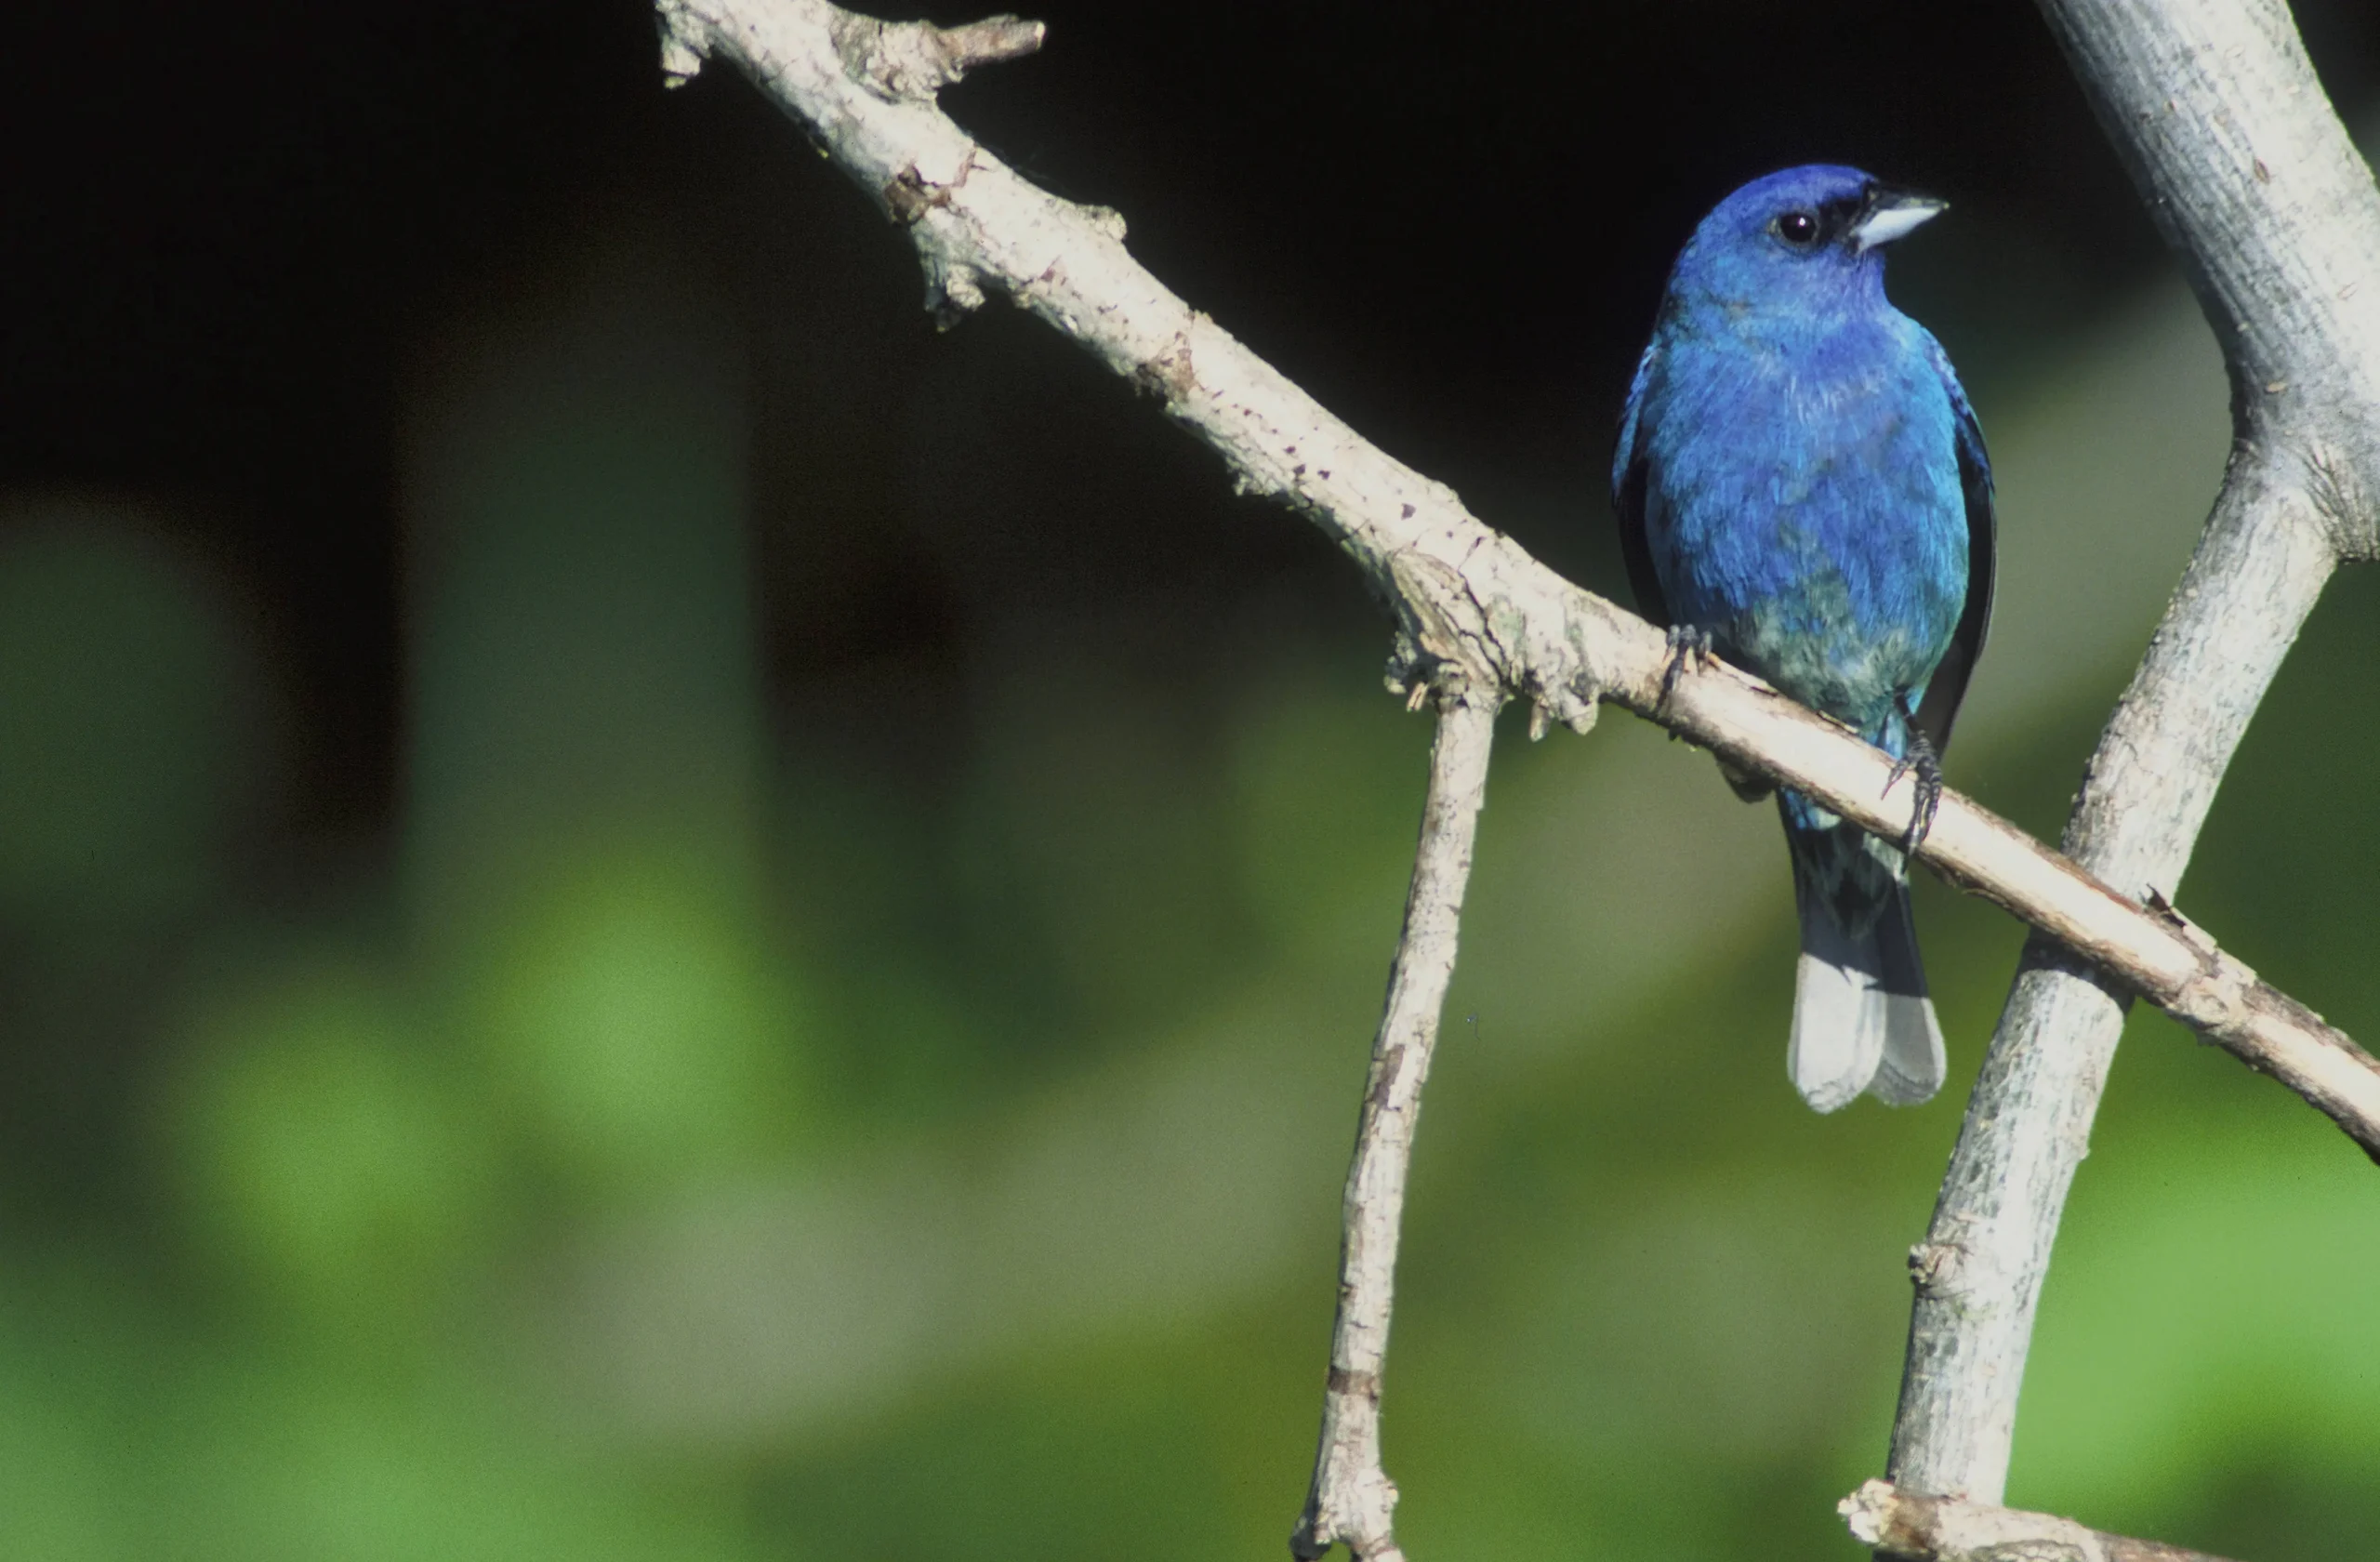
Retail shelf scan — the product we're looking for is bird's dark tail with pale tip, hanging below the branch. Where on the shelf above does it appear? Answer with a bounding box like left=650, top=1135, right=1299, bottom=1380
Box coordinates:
left=1780, top=793, right=1945, bottom=1112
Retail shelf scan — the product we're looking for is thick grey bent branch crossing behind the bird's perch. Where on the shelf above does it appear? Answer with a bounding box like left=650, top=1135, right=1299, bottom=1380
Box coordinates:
left=1890, top=0, right=2380, bottom=1502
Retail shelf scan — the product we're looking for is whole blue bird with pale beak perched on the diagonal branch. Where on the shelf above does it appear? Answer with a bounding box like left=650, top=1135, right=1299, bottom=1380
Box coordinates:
left=1611, top=165, right=1994, bottom=1112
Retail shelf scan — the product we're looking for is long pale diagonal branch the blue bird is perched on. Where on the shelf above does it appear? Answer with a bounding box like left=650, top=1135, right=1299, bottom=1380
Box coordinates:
left=659, top=0, right=2380, bottom=1158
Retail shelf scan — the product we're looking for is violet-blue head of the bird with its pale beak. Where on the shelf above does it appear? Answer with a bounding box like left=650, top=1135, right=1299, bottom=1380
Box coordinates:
left=1669, top=162, right=1945, bottom=311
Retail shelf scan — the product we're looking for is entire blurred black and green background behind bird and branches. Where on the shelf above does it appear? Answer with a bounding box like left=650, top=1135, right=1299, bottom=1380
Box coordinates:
left=0, top=0, right=2380, bottom=1562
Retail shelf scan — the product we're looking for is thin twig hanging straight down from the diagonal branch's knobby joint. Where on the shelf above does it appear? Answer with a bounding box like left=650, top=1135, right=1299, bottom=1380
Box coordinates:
left=1290, top=688, right=1504, bottom=1562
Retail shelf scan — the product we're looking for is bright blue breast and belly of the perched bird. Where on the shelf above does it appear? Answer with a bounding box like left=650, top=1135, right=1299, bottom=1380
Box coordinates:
left=1633, top=300, right=1968, bottom=750
